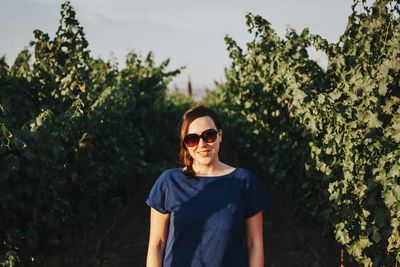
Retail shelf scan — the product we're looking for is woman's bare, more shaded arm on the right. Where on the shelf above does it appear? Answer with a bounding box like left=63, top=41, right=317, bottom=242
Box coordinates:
left=246, top=211, right=264, bottom=267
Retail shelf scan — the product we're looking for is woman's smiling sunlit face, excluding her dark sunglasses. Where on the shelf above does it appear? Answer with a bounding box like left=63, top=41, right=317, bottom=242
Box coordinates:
left=187, top=116, right=222, bottom=165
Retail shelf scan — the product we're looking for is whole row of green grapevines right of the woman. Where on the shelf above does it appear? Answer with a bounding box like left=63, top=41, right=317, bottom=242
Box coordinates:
left=206, top=0, right=400, bottom=266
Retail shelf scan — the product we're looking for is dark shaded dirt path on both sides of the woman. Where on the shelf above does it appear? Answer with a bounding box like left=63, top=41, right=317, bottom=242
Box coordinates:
left=45, top=177, right=358, bottom=267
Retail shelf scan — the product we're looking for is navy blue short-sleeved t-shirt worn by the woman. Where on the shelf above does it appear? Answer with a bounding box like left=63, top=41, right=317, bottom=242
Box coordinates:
left=146, top=168, right=270, bottom=267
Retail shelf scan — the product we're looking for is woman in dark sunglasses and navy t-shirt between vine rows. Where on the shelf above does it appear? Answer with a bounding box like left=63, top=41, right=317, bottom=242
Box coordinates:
left=146, top=105, right=269, bottom=267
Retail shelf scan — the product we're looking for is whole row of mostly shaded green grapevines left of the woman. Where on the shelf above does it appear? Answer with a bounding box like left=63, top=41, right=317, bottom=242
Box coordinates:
left=0, top=2, right=184, bottom=266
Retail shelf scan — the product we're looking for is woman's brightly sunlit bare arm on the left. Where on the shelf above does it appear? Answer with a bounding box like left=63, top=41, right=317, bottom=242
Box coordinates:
left=146, top=208, right=170, bottom=267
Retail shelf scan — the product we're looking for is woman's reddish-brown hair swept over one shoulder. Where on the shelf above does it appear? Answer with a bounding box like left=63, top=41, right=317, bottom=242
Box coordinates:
left=179, top=104, right=221, bottom=177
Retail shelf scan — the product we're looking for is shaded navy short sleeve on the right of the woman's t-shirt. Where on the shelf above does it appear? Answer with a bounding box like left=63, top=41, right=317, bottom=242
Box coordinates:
left=245, top=173, right=271, bottom=219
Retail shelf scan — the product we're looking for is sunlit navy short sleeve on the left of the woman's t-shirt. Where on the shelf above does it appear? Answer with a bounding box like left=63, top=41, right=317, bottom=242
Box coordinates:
left=145, top=172, right=168, bottom=214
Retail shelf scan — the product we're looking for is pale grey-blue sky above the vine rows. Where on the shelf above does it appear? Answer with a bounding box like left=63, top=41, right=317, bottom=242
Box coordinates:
left=0, top=0, right=352, bottom=98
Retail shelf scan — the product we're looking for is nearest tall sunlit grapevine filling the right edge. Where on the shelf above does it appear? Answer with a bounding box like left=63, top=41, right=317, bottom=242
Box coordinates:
left=322, top=1, right=400, bottom=266
